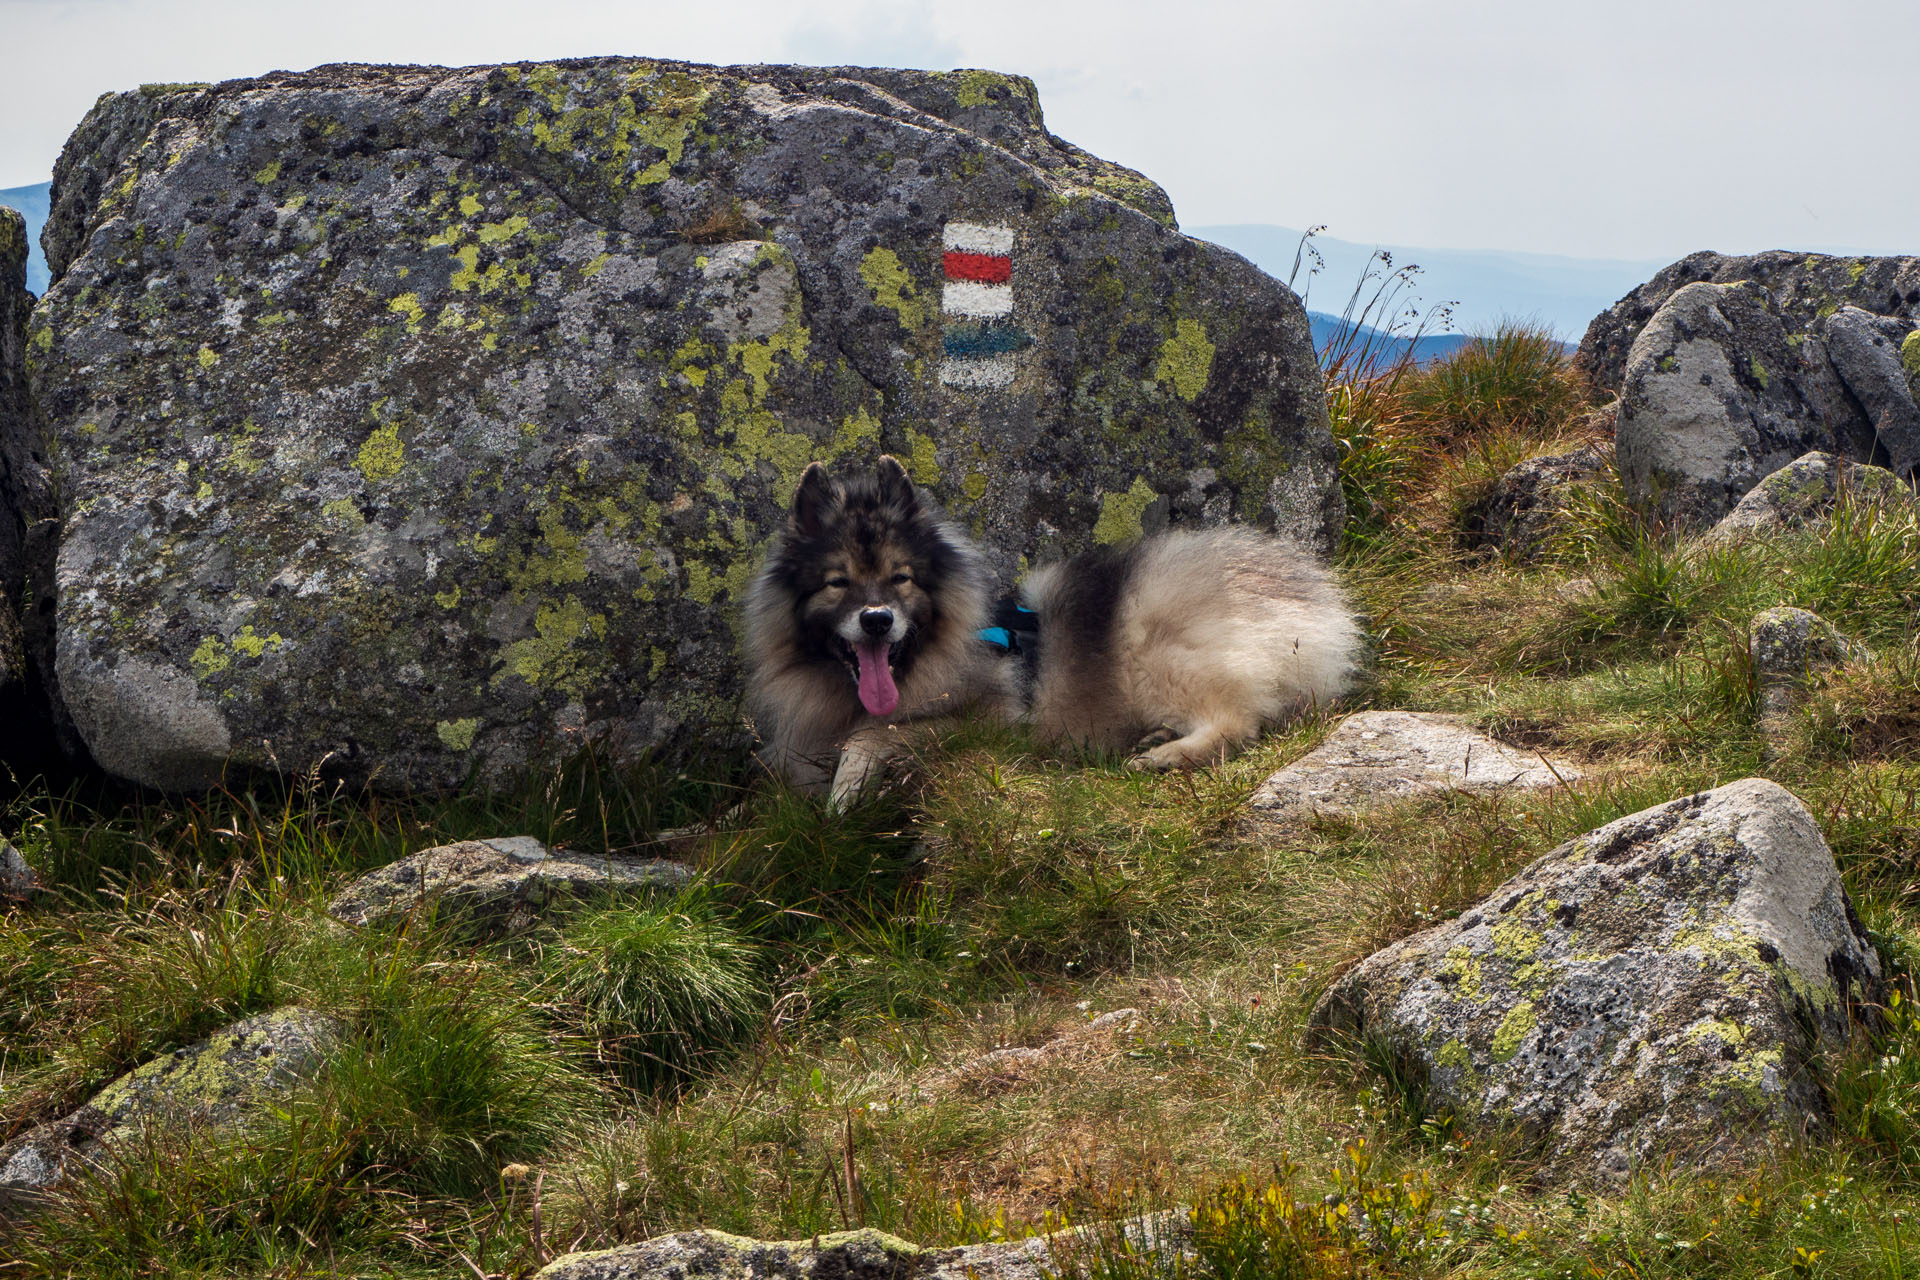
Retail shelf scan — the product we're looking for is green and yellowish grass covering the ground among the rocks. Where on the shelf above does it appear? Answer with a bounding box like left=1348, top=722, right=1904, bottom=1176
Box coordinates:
left=0, top=345, right=1920, bottom=1280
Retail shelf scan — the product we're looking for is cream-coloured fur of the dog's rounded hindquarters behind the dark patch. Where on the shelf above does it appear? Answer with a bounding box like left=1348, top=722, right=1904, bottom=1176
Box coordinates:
left=1021, top=528, right=1361, bottom=770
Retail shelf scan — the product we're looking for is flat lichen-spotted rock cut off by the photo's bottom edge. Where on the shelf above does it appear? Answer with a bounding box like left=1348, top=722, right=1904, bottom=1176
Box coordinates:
left=536, top=1211, right=1190, bottom=1280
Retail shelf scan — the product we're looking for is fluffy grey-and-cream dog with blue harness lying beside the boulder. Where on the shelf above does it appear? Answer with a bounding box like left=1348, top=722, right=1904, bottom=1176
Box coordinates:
left=747, top=457, right=1361, bottom=808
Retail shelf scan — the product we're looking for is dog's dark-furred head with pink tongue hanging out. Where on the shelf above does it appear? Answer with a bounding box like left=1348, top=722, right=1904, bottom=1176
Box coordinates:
left=772, top=457, right=966, bottom=716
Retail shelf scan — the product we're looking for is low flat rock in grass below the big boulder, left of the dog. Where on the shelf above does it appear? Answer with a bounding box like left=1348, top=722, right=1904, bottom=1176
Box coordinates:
left=326, top=835, right=693, bottom=933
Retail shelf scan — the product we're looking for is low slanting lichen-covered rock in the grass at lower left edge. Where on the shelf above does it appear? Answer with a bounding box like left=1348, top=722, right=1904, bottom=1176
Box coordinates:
left=0, top=1009, right=340, bottom=1213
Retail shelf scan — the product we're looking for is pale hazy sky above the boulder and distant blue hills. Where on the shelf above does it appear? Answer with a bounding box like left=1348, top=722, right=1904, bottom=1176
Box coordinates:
left=0, top=0, right=1920, bottom=259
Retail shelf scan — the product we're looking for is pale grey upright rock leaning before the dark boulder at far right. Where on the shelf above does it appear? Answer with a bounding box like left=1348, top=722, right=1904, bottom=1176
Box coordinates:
left=1615, top=282, right=1834, bottom=526
